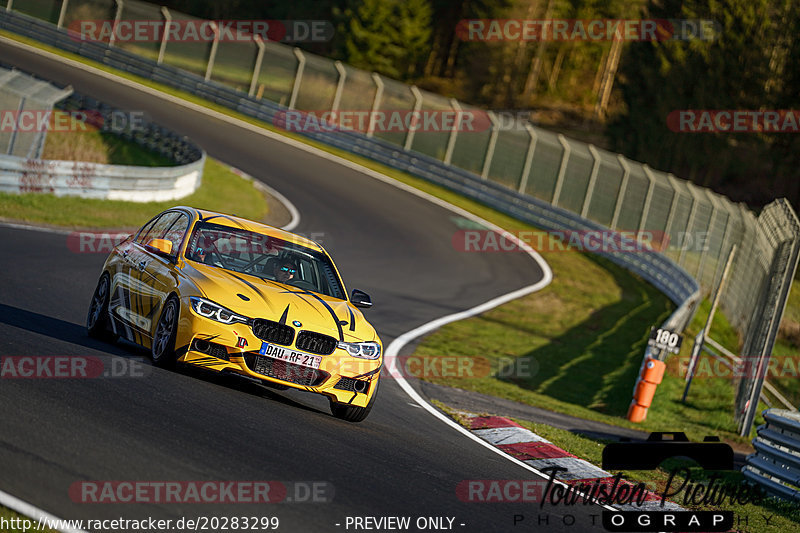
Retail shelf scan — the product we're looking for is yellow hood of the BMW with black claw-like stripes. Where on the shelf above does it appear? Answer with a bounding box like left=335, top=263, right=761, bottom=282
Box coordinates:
left=183, top=261, right=377, bottom=342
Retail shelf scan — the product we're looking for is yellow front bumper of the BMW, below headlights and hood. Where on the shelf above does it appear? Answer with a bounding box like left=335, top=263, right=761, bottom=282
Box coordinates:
left=175, top=305, right=383, bottom=407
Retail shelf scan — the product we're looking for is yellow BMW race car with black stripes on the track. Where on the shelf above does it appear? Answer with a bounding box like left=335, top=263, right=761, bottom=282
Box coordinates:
left=86, top=207, right=383, bottom=422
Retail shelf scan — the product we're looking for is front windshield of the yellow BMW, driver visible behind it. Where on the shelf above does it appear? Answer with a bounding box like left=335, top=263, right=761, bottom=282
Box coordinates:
left=186, top=218, right=345, bottom=300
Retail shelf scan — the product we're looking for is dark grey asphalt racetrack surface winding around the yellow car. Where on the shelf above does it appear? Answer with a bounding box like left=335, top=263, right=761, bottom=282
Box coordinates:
left=0, top=44, right=602, bottom=532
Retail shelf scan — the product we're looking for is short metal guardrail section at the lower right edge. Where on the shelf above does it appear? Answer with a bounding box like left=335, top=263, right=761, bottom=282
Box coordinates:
left=742, top=409, right=800, bottom=502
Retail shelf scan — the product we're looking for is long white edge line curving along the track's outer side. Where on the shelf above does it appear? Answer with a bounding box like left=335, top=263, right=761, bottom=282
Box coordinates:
left=0, top=31, right=615, bottom=510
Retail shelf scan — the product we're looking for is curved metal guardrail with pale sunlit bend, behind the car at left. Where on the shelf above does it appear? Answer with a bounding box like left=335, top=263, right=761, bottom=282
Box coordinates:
left=0, top=59, right=205, bottom=202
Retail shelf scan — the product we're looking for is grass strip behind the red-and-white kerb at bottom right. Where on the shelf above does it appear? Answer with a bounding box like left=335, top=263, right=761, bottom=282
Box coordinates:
left=434, top=402, right=800, bottom=533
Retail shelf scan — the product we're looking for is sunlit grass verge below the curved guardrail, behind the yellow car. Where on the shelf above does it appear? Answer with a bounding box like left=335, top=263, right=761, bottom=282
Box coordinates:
left=0, top=158, right=267, bottom=229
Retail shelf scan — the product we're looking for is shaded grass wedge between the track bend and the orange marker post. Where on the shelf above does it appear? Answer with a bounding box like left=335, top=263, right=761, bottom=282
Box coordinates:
left=497, top=258, right=672, bottom=416
